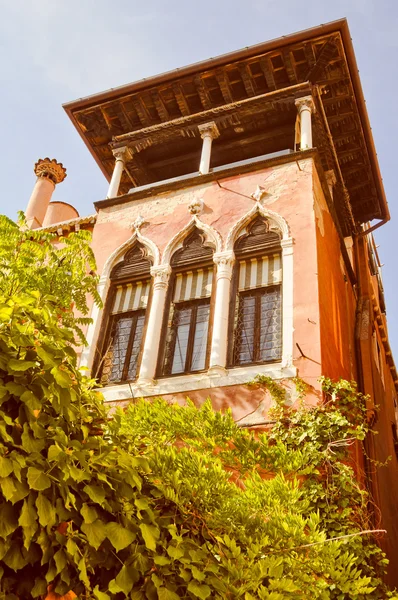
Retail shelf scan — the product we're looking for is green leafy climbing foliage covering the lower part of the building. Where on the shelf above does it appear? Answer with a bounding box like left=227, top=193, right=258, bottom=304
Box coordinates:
left=0, top=218, right=397, bottom=600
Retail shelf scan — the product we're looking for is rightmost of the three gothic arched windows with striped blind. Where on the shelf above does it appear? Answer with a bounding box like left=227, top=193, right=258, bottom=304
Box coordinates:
left=229, top=216, right=282, bottom=366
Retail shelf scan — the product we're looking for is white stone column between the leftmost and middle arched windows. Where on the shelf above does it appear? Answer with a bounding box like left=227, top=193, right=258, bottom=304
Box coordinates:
left=137, top=265, right=171, bottom=386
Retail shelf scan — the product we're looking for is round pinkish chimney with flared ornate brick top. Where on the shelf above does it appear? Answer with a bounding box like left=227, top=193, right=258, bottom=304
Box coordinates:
left=25, top=158, right=66, bottom=229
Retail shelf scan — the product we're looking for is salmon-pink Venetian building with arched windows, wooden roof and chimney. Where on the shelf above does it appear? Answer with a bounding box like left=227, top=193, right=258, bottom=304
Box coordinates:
left=27, top=20, right=398, bottom=584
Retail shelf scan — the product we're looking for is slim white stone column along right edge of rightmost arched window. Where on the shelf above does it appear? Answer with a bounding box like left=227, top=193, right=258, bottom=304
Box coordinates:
left=281, top=238, right=294, bottom=367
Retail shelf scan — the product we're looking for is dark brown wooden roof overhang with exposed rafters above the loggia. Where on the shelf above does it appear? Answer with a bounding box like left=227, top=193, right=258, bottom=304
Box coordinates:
left=64, top=19, right=389, bottom=235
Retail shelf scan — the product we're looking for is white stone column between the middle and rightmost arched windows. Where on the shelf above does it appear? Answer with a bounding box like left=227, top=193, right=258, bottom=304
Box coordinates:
left=209, top=251, right=235, bottom=375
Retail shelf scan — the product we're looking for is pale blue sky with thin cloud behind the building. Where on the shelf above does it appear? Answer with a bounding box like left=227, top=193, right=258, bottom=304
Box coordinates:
left=0, top=0, right=398, bottom=360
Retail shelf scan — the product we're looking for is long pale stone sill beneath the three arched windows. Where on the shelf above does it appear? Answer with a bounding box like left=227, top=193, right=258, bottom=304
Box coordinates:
left=98, top=362, right=297, bottom=402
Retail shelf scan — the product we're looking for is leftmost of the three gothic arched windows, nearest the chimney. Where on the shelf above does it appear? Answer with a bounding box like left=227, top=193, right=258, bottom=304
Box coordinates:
left=96, top=243, right=151, bottom=384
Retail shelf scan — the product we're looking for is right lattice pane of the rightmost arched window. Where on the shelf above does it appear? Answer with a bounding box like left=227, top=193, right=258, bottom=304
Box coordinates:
left=259, top=288, right=282, bottom=361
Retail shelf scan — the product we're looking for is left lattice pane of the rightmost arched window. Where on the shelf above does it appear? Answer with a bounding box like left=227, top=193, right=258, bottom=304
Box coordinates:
left=234, top=295, right=256, bottom=365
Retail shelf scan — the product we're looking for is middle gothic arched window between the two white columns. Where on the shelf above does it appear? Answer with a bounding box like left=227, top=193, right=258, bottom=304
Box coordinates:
left=159, top=228, right=214, bottom=376
